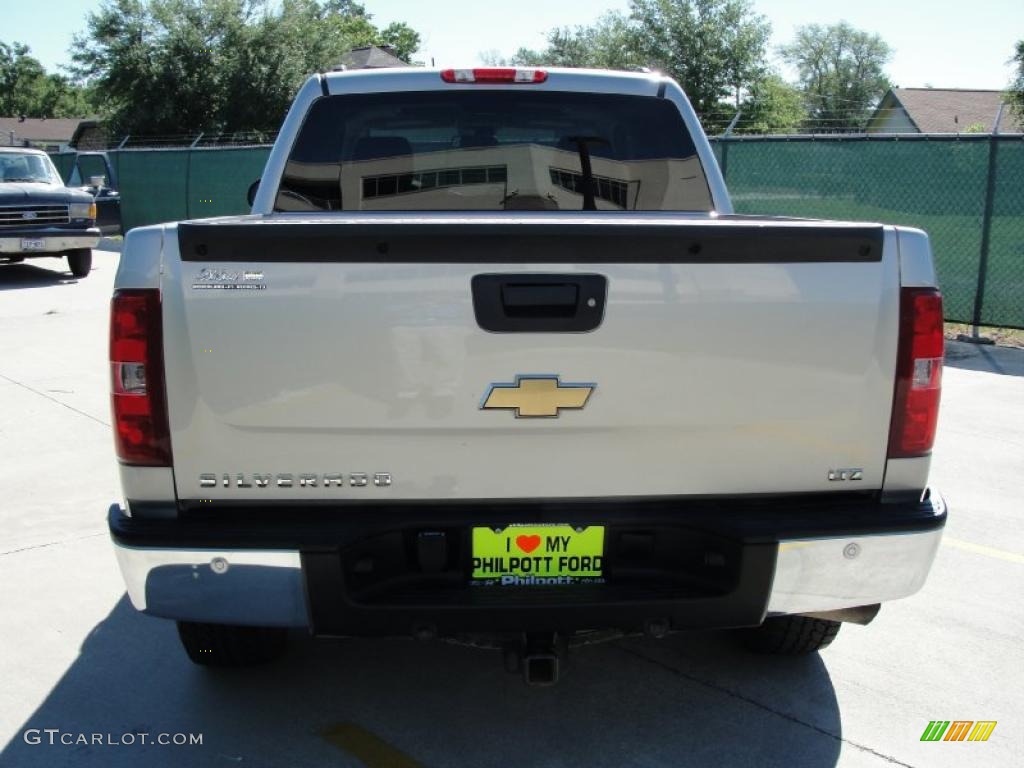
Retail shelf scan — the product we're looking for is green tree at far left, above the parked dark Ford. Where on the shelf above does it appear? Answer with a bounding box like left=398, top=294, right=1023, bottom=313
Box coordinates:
left=0, top=42, right=89, bottom=118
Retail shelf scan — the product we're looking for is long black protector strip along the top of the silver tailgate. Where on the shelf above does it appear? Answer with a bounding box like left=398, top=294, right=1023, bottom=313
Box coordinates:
left=178, top=218, right=884, bottom=264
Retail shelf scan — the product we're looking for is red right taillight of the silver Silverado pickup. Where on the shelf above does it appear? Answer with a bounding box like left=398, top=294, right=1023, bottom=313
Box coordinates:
left=889, top=288, right=944, bottom=459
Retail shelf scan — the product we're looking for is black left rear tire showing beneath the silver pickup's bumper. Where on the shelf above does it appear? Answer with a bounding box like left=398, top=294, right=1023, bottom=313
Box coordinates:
left=178, top=622, right=288, bottom=667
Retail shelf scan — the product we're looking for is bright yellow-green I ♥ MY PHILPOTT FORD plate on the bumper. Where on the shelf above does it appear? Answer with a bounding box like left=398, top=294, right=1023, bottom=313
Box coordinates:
left=472, top=525, right=604, bottom=587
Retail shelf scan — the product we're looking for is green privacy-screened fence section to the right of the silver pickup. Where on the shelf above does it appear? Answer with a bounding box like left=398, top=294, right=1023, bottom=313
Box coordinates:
left=714, top=135, right=1024, bottom=328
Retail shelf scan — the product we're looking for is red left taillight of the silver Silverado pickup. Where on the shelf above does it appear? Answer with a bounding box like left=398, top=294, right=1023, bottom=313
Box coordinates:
left=111, top=289, right=171, bottom=467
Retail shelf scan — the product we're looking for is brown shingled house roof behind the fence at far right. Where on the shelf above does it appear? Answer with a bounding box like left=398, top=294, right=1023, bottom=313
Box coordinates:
left=876, top=88, right=1022, bottom=133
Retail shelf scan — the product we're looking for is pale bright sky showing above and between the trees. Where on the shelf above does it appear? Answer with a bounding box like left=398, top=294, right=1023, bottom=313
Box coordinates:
left=8, top=0, right=1024, bottom=89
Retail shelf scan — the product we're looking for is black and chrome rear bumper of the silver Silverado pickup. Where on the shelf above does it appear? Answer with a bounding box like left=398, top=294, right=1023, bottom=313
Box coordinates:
left=109, top=492, right=946, bottom=635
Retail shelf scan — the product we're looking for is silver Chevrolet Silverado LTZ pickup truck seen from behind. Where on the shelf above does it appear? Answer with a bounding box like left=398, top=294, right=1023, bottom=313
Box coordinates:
left=109, top=69, right=946, bottom=684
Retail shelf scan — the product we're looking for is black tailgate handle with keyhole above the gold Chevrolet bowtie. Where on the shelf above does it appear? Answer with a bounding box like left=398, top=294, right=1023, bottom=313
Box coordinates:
left=472, top=273, right=608, bottom=333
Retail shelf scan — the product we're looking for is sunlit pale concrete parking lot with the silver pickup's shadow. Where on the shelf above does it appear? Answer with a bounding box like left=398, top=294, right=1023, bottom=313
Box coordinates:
left=0, top=251, right=1024, bottom=768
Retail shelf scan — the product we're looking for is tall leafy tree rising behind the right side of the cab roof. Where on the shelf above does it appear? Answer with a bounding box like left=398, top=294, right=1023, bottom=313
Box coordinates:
left=632, top=0, right=771, bottom=130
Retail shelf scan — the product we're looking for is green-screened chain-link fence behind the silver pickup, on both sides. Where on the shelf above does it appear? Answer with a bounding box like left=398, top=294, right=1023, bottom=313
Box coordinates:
left=55, top=134, right=1024, bottom=328
